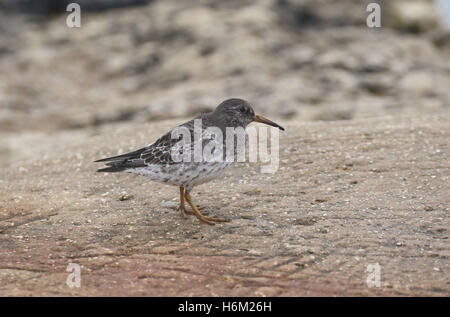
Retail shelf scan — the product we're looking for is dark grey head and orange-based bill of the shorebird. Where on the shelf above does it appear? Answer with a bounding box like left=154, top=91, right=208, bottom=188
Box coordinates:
left=213, top=98, right=284, bottom=131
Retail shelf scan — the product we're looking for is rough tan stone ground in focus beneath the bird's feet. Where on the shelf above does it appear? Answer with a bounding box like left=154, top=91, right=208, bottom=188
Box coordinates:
left=0, top=114, right=450, bottom=296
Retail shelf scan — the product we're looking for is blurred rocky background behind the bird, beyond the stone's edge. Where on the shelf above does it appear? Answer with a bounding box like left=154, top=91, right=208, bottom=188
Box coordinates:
left=0, top=0, right=450, bottom=167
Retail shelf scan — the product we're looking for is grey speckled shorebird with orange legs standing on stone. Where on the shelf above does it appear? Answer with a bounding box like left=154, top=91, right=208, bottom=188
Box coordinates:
left=95, top=98, right=284, bottom=225
